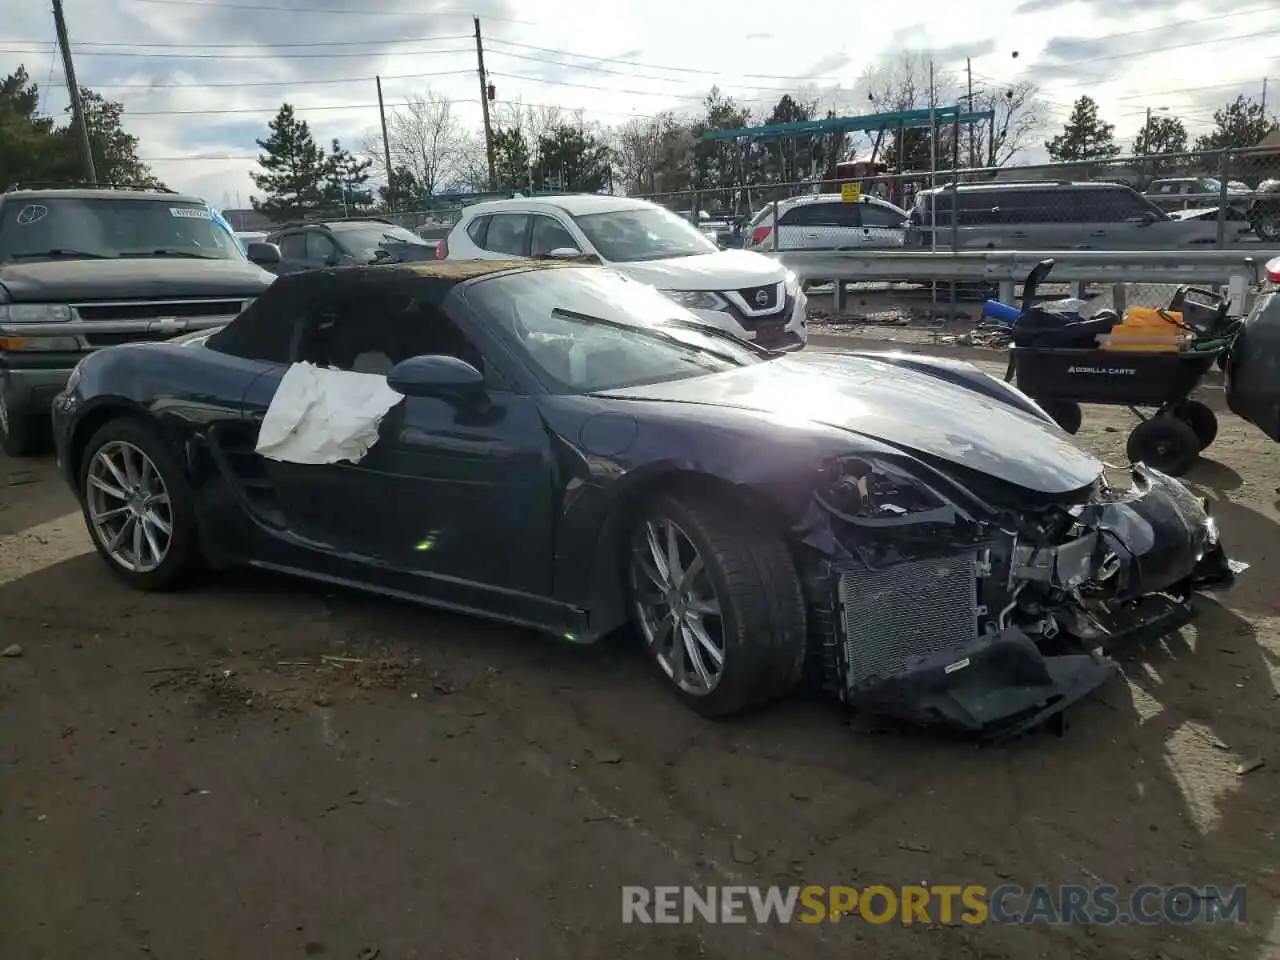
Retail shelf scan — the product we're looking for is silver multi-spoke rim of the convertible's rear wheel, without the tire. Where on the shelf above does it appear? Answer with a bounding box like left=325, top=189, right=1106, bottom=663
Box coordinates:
left=84, top=440, right=173, bottom=573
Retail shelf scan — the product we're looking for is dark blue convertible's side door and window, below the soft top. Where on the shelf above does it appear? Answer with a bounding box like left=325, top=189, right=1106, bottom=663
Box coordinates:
left=247, top=284, right=553, bottom=607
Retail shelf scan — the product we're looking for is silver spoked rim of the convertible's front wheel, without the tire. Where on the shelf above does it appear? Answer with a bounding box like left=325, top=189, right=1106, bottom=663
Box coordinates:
left=631, top=517, right=724, bottom=696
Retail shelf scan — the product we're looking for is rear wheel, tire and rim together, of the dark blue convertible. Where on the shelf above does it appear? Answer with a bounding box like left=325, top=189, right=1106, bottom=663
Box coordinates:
left=79, top=420, right=198, bottom=590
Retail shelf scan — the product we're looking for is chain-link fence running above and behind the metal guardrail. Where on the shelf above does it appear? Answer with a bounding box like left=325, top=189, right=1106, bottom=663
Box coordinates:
left=629, top=148, right=1280, bottom=252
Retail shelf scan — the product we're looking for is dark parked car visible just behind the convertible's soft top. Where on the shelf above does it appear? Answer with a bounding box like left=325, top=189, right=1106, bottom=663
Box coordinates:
left=255, top=219, right=436, bottom=274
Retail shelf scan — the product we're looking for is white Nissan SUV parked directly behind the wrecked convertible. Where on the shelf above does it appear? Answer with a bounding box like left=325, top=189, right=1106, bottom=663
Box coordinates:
left=438, top=193, right=809, bottom=351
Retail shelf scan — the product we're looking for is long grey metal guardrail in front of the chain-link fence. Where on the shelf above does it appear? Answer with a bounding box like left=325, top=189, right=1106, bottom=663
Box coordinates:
left=768, top=247, right=1280, bottom=312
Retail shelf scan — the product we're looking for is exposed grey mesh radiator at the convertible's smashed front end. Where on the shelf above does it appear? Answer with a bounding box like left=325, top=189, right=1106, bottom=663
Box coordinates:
left=838, top=553, right=979, bottom=687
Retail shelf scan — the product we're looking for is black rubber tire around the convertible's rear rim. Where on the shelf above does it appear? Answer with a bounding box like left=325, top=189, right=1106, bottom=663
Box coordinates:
left=76, top=416, right=201, bottom=591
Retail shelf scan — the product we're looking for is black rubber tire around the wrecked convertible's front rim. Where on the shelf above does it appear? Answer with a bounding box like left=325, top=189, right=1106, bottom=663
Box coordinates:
left=626, top=493, right=808, bottom=717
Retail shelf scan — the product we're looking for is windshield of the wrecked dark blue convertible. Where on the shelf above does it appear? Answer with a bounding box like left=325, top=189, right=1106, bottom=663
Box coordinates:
left=466, top=268, right=763, bottom=393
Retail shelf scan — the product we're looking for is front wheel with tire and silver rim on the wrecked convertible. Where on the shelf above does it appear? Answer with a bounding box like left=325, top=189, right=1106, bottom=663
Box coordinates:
left=628, top=497, right=806, bottom=717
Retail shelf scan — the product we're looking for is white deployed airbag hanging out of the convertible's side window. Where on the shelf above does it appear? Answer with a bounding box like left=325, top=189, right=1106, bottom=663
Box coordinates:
left=257, top=364, right=404, bottom=463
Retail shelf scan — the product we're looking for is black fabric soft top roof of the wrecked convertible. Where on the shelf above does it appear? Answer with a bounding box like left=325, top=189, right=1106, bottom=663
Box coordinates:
left=206, top=260, right=584, bottom=361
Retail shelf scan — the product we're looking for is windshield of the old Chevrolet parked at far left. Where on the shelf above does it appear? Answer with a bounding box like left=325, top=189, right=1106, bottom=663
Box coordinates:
left=0, top=196, right=244, bottom=260
